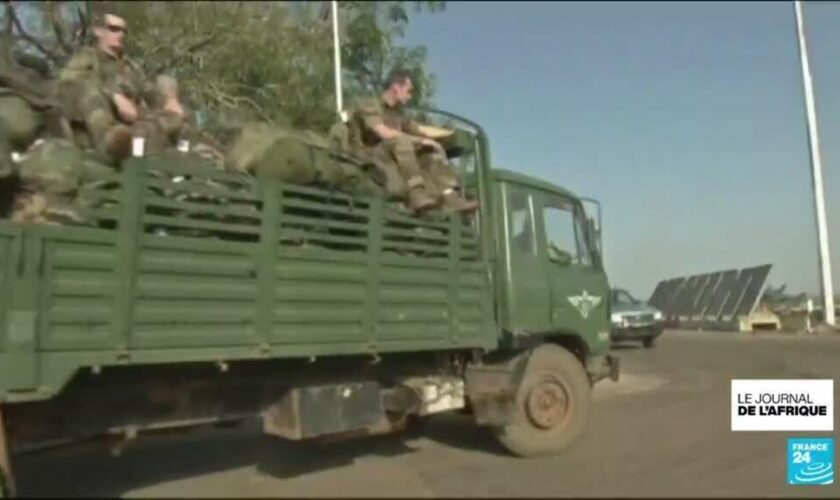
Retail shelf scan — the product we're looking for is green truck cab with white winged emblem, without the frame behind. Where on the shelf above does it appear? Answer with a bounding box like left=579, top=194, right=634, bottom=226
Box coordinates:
left=492, top=169, right=610, bottom=378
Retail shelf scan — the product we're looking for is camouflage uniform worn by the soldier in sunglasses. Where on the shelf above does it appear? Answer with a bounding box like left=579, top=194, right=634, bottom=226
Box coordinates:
left=58, top=47, right=182, bottom=162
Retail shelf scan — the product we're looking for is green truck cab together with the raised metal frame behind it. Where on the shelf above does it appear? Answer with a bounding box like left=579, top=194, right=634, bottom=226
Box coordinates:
left=416, top=109, right=618, bottom=381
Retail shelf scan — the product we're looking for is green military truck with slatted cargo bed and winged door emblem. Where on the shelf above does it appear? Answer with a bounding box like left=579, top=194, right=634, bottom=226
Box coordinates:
left=0, top=111, right=618, bottom=495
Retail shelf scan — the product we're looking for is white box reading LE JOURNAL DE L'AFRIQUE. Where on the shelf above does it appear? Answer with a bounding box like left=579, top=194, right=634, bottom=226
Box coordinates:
left=730, top=379, right=834, bottom=432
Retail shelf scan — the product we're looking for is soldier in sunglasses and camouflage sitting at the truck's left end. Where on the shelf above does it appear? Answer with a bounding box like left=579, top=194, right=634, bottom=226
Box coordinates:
left=58, top=14, right=185, bottom=164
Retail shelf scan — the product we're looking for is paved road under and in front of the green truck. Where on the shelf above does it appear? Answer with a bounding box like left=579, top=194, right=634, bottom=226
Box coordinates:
left=11, top=332, right=840, bottom=497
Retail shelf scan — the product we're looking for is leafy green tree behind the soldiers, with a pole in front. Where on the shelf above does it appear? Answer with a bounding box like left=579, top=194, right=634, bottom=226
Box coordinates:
left=3, top=1, right=444, bottom=130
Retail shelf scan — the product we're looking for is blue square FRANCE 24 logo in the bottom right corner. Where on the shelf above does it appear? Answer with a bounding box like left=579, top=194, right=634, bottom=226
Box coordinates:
left=788, top=438, right=834, bottom=485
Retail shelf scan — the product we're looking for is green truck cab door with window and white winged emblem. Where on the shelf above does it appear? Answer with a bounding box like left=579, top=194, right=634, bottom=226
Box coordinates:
left=538, top=192, right=609, bottom=338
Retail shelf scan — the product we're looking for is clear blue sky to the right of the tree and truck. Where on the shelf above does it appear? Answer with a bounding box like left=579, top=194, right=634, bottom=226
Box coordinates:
left=404, top=2, right=840, bottom=299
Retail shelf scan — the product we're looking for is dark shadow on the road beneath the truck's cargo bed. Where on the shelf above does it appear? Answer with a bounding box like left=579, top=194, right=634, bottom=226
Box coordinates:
left=15, top=422, right=424, bottom=498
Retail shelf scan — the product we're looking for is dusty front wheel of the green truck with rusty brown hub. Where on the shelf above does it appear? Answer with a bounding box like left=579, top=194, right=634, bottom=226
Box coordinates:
left=494, top=344, right=591, bottom=457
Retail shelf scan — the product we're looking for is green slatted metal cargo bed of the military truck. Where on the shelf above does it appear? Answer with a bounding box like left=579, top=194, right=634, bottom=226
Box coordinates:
left=0, top=158, right=497, bottom=402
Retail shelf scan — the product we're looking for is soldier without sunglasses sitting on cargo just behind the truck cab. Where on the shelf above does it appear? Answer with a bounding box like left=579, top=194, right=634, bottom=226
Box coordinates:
left=349, top=71, right=478, bottom=212
